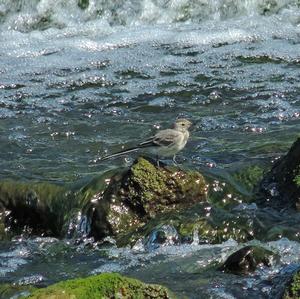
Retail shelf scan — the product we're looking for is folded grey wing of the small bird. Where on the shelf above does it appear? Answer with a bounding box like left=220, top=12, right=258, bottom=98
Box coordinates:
left=139, top=129, right=182, bottom=146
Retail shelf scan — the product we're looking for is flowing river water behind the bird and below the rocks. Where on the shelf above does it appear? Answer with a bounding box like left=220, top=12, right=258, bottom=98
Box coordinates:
left=0, top=0, right=300, bottom=298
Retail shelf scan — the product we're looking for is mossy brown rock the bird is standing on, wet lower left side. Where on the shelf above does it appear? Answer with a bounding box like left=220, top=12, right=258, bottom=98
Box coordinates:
left=87, top=158, right=207, bottom=240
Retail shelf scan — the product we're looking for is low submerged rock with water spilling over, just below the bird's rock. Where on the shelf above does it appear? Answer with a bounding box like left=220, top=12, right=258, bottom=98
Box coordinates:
left=117, top=202, right=254, bottom=249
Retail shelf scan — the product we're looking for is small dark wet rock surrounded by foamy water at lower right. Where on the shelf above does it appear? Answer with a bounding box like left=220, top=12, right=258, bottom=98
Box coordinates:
left=219, top=246, right=278, bottom=274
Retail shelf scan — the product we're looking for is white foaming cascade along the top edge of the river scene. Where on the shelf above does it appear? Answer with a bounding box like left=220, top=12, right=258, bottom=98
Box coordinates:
left=0, top=0, right=300, bottom=31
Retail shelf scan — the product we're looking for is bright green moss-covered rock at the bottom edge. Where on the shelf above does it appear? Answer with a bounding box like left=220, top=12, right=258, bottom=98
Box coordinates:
left=26, top=273, right=175, bottom=299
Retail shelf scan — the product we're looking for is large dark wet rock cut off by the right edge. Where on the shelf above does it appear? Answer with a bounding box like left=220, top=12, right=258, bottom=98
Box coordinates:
left=258, top=138, right=300, bottom=211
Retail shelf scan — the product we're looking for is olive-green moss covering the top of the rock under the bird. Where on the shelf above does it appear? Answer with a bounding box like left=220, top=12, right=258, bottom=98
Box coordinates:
left=124, top=158, right=206, bottom=215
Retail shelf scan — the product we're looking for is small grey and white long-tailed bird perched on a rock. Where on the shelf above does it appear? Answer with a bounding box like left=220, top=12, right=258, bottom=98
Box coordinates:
left=98, top=118, right=192, bottom=165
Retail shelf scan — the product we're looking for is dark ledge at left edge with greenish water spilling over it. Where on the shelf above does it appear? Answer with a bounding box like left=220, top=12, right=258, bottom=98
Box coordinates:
left=0, top=181, right=78, bottom=239
